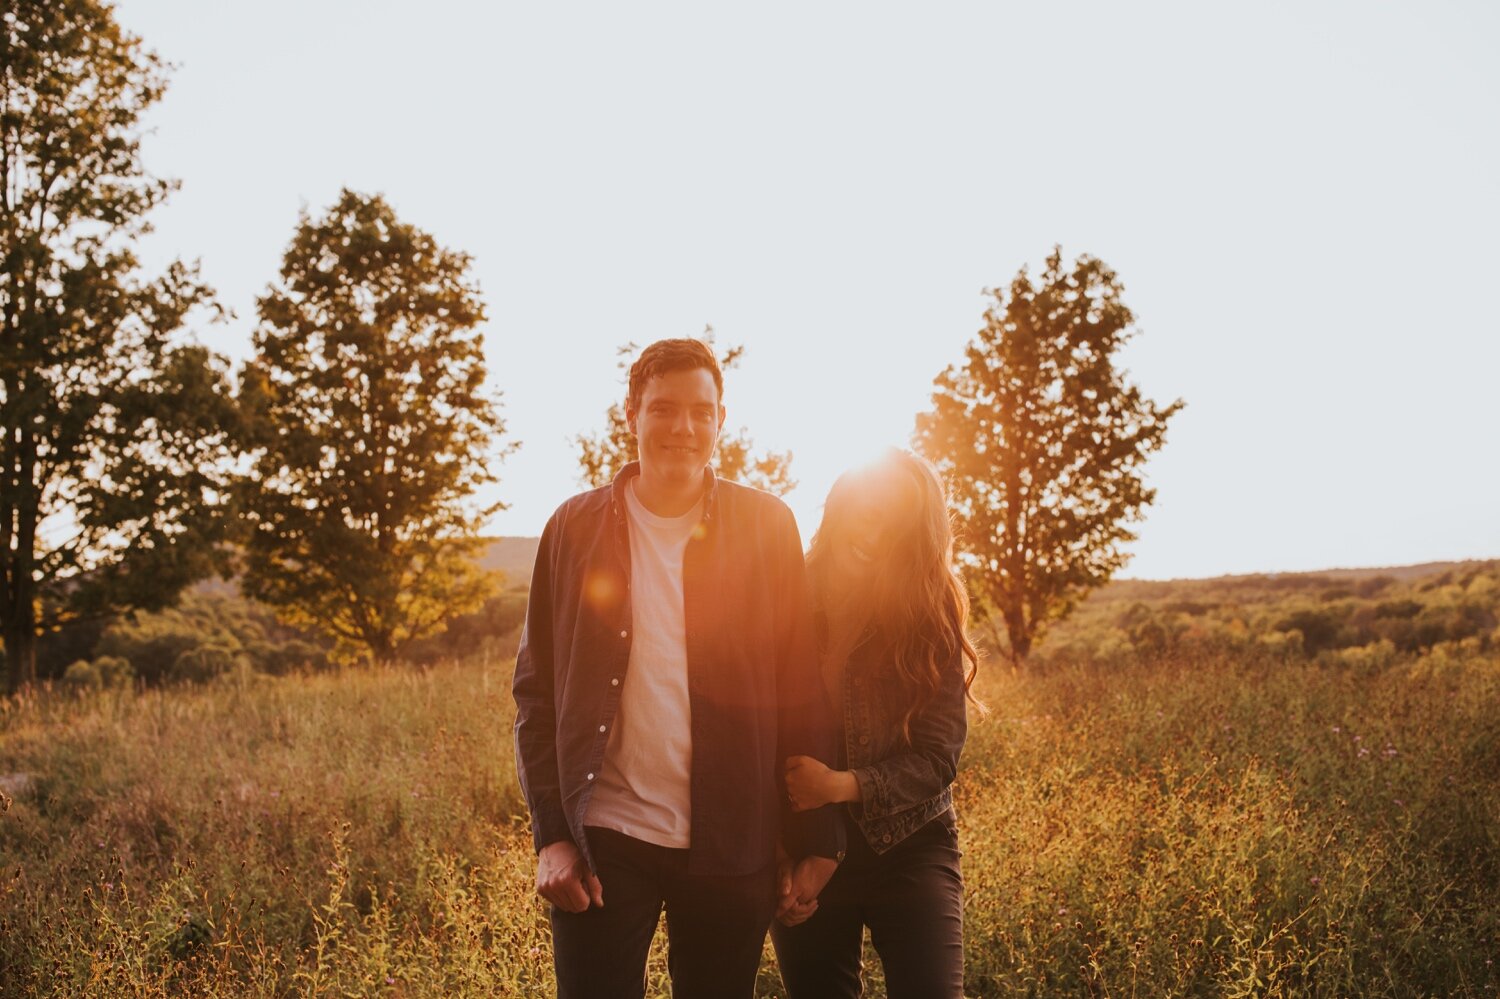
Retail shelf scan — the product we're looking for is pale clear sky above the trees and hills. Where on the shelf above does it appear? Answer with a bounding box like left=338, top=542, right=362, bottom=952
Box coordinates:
left=117, top=0, right=1500, bottom=579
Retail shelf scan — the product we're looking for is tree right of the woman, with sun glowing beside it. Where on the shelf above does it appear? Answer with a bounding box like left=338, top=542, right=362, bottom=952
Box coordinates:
left=915, top=248, right=1182, bottom=663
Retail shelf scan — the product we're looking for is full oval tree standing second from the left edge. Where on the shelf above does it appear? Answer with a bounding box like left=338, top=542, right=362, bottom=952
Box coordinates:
left=242, top=191, right=510, bottom=662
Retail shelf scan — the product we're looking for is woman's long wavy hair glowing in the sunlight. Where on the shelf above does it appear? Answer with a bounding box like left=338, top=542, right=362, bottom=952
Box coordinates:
left=807, top=447, right=980, bottom=743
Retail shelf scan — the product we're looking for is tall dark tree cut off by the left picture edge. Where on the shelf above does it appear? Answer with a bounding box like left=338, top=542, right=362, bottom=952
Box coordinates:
left=0, top=0, right=236, bottom=690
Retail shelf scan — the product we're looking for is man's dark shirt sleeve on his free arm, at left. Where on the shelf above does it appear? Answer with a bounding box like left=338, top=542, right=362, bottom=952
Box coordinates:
left=512, top=515, right=573, bottom=852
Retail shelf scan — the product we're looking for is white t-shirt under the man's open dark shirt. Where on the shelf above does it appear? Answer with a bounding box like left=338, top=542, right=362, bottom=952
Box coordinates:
left=585, top=480, right=704, bottom=849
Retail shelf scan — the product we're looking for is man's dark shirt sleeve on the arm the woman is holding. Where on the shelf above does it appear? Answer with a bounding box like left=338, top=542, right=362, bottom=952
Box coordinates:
left=774, top=506, right=845, bottom=860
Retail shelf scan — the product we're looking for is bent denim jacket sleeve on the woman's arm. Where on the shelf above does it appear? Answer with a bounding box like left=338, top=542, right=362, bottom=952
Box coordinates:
left=854, top=651, right=969, bottom=819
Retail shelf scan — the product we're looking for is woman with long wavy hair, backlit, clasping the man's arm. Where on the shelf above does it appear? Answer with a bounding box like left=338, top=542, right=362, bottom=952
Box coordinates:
left=771, top=449, right=978, bottom=999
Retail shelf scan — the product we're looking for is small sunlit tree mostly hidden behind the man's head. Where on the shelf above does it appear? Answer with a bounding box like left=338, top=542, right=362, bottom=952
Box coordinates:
left=573, top=327, right=797, bottom=497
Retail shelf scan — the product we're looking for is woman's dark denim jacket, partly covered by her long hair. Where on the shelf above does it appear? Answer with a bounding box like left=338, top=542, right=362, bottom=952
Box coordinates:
left=843, top=638, right=969, bottom=854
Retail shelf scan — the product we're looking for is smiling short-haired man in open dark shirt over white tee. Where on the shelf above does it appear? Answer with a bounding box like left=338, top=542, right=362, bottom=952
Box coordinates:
left=515, top=339, right=843, bottom=999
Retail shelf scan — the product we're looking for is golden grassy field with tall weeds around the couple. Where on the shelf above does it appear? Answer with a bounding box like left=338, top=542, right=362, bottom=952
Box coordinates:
left=0, top=642, right=1500, bottom=998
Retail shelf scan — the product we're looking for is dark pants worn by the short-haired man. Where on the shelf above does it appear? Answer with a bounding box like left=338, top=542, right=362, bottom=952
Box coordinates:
left=552, top=828, right=776, bottom=999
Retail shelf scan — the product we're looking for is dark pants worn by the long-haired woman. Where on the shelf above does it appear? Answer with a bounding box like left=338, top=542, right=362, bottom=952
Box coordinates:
left=771, top=813, right=963, bottom=999
